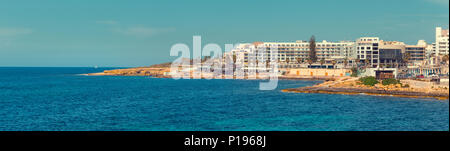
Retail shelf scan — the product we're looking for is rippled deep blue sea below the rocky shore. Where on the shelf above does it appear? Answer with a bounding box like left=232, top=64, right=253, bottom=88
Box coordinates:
left=0, top=68, right=449, bottom=131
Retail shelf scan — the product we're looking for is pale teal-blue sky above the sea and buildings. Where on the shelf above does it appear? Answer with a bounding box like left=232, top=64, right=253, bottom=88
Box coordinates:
left=0, top=0, right=449, bottom=67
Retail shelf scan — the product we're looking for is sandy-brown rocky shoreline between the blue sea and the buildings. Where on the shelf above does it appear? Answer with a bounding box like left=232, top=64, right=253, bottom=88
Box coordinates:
left=86, top=67, right=449, bottom=100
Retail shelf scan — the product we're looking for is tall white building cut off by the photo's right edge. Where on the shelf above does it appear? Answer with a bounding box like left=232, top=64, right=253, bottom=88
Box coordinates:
left=435, top=27, right=449, bottom=55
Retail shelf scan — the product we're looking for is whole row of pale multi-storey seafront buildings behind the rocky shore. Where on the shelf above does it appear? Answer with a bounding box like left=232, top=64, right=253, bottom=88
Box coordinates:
left=228, top=27, right=449, bottom=72
